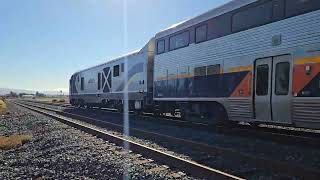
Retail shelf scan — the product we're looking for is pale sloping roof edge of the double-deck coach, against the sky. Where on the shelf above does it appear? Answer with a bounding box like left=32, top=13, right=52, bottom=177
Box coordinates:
left=156, top=0, right=258, bottom=38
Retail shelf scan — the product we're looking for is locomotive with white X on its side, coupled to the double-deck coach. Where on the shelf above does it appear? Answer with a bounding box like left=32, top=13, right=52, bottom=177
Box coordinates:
left=70, top=39, right=154, bottom=110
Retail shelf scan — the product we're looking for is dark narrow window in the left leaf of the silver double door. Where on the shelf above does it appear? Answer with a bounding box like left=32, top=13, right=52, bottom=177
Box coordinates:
left=256, top=64, right=269, bottom=96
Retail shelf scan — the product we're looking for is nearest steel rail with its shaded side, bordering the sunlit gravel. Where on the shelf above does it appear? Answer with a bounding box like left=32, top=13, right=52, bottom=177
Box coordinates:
left=16, top=103, right=243, bottom=180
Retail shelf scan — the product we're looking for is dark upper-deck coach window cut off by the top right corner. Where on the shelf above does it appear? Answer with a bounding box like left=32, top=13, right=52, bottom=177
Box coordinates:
left=286, top=0, right=320, bottom=17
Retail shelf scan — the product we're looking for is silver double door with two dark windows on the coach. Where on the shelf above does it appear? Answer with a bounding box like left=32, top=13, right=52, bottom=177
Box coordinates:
left=254, top=55, right=292, bottom=123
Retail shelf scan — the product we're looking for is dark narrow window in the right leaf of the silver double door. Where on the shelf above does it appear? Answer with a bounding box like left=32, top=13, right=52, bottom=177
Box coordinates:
left=275, top=62, right=290, bottom=95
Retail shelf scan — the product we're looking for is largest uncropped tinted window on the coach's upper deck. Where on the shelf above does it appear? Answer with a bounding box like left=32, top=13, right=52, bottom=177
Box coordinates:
left=232, top=1, right=273, bottom=32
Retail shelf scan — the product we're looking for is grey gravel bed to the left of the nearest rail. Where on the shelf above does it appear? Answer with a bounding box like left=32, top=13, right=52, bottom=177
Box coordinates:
left=0, top=103, right=193, bottom=179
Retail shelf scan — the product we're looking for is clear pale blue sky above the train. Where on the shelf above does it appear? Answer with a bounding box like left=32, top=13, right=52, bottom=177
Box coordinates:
left=0, top=0, right=230, bottom=91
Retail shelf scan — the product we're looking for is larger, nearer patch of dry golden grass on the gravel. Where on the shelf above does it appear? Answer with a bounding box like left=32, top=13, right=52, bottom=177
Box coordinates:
left=0, top=135, right=32, bottom=150
